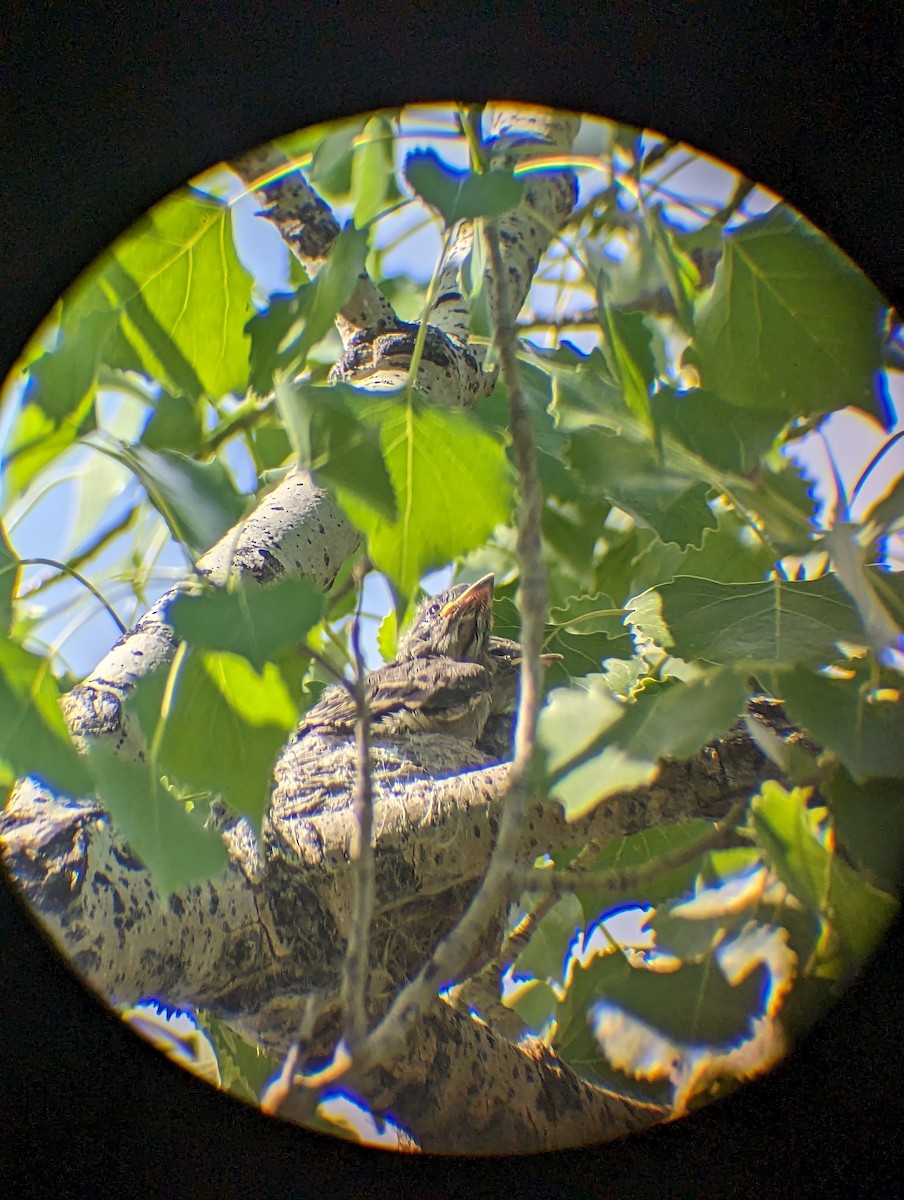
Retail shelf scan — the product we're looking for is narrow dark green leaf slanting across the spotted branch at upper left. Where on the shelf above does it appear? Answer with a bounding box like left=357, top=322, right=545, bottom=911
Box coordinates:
left=246, top=227, right=367, bottom=396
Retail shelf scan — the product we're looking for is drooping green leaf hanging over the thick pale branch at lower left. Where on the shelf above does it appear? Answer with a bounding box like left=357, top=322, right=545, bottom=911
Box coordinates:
left=88, top=742, right=228, bottom=896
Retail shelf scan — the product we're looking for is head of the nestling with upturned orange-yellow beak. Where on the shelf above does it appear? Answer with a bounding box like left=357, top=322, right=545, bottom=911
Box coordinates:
left=397, top=575, right=495, bottom=662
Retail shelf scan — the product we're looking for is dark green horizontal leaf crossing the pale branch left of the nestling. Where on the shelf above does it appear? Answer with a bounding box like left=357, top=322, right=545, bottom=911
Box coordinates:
left=166, top=578, right=324, bottom=671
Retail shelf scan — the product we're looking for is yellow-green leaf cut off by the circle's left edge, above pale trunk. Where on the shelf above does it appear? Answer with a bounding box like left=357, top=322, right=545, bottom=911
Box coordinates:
left=0, top=638, right=91, bottom=796
